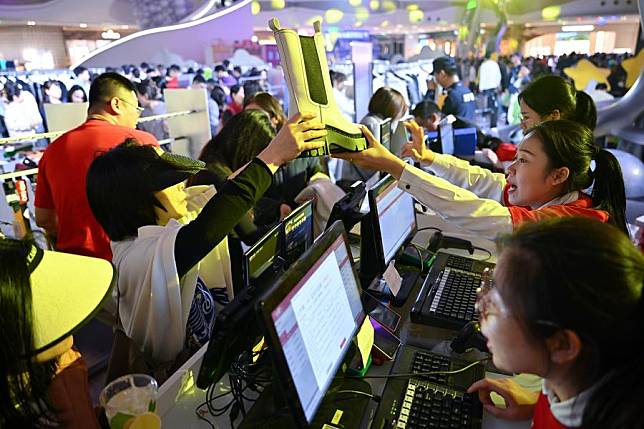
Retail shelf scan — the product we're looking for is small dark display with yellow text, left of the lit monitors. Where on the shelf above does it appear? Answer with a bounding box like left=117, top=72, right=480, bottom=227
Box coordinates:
left=282, top=201, right=313, bottom=268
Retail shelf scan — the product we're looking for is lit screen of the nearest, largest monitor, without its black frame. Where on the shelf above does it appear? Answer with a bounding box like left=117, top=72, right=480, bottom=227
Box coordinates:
left=269, top=229, right=364, bottom=423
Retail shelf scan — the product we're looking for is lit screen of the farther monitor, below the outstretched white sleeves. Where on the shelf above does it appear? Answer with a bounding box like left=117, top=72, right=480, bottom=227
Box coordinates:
left=375, top=179, right=416, bottom=266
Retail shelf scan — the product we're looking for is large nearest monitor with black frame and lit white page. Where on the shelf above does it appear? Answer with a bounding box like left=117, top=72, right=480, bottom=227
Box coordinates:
left=257, top=222, right=364, bottom=427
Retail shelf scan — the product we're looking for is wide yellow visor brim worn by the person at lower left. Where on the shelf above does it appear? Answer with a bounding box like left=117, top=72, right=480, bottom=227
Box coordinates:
left=27, top=246, right=115, bottom=354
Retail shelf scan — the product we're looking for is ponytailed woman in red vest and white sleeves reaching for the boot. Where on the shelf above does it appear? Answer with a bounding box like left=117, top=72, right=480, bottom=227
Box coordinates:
left=336, top=120, right=627, bottom=239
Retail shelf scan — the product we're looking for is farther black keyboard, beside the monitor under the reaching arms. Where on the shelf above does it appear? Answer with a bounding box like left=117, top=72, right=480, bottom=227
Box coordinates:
left=411, top=252, right=494, bottom=330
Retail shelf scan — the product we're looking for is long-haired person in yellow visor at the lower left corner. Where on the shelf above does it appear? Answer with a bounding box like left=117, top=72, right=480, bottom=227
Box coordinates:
left=0, top=238, right=114, bottom=429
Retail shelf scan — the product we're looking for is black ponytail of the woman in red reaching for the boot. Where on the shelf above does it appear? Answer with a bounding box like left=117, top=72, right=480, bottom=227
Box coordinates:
left=591, top=149, right=628, bottom=234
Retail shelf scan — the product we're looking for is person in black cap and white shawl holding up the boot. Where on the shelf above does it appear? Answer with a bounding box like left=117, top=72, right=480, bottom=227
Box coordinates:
left=87, top=114, right=326, bottom=377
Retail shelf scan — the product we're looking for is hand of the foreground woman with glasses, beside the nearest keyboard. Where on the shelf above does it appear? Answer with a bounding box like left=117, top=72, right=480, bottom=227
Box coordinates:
left=467, top=378, right=539, bottom=420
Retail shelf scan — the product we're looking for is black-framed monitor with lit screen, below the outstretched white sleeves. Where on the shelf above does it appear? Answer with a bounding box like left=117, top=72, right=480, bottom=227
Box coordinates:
left=360, top=175, right=417, bottom=287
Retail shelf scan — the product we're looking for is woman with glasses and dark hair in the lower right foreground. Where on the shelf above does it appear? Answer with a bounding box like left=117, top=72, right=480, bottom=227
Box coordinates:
left=469, top=218, right=644, bottom=429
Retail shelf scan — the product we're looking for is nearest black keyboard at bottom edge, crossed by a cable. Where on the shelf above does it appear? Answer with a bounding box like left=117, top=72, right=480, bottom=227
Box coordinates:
left=372, top=348, right=484, bottom=429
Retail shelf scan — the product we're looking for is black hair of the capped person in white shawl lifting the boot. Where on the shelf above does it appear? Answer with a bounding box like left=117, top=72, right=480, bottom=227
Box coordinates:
left=86, top=138, right=167, bottom=241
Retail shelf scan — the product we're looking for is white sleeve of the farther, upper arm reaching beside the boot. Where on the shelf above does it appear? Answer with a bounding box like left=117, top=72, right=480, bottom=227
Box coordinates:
left=426, top=153, right=506, bottom=202
